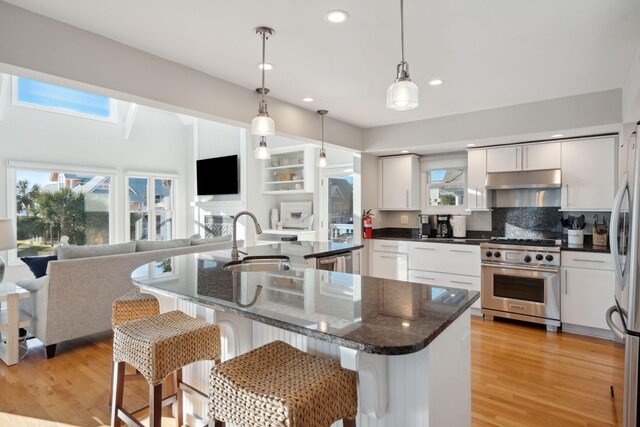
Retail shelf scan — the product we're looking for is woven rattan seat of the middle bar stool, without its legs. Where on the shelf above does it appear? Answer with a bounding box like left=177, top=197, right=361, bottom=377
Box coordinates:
left=113, top=311, right=220, bottom=385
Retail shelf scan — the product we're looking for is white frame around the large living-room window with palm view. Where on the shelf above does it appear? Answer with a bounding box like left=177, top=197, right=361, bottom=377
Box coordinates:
left=7, top=160, right=119, bottom=267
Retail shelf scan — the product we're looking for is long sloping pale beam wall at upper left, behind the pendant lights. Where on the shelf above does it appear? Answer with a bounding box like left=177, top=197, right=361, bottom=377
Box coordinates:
left=0, top=1, right=362, bottom=149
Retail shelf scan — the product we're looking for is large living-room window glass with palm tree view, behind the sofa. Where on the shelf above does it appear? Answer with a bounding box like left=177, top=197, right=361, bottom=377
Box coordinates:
left=9, top=167, right=113, bottom=257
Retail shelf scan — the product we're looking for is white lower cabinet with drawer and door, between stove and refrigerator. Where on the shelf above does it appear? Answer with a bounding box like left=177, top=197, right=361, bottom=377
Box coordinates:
left=560, top=251, right=615, bottom=336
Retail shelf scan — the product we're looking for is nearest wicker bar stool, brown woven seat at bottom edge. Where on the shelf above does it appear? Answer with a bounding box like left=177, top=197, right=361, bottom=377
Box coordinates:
left=209, top=341, right=358, bottom=427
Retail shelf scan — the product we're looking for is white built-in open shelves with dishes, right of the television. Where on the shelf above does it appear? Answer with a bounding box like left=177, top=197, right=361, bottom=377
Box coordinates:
left=263, top=146, right=317, bottom=194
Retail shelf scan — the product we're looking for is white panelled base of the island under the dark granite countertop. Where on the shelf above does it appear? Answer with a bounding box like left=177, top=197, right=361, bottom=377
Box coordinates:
left=145, top=290, right=471, bottom=427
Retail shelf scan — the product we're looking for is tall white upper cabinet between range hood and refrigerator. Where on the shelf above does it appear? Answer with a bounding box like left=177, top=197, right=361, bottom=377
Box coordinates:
left=561, top=137, right=617, bottom=211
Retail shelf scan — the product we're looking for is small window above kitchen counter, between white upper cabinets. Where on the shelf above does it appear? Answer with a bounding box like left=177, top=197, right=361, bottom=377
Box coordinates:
left=427, top=168, right=467, bottom=208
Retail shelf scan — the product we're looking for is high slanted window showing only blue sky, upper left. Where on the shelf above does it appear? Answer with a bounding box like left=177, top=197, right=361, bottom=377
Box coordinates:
left=13, top=77, right=116, bottom=122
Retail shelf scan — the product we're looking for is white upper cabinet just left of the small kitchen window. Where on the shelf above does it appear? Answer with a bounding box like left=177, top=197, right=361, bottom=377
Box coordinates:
left=378, top=154, right=420, bottom=210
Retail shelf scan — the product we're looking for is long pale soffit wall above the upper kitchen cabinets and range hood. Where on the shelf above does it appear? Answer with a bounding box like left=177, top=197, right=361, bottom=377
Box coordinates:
left=363, top=89, right=622, bottom=154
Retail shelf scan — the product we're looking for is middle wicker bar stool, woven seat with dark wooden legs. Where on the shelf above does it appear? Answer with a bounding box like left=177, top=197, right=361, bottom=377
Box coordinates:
left=111, top=311, right=220, bottom=427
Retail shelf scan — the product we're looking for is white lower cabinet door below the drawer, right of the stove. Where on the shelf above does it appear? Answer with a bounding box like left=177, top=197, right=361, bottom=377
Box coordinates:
left=560, top=267, right=615, bottom=330
